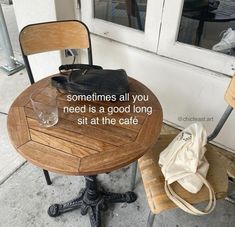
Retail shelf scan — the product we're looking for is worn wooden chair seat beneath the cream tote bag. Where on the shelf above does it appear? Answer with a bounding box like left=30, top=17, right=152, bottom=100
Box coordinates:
left=139, top=134, right=228, bottom=214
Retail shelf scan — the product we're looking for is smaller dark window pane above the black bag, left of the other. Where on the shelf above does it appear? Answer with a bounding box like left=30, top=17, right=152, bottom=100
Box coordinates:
left=94, top=0, right=147, bottom=31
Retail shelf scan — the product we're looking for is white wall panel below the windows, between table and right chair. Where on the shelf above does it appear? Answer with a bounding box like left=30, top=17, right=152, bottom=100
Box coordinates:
left=84, top=35, right=235, bottom=151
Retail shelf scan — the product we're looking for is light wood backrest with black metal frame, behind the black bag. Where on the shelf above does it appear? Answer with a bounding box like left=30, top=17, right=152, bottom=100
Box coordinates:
left=19, top=20, right=93, bottom=83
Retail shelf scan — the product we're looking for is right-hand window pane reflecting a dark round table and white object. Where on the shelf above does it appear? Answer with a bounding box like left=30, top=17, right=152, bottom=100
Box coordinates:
left=178, top=0, right=235, bottom=56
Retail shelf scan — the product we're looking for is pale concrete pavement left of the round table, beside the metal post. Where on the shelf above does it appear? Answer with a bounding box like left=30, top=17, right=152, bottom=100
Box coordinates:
left=0, top=4, right=30, bottom=183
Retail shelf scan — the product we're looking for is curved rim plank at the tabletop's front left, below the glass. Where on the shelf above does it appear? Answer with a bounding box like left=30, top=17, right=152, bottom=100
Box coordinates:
left=18, top=141, right=80, bottom=175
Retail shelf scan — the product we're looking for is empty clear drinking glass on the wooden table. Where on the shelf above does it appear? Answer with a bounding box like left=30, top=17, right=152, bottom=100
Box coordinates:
left=30, top=87, right=58, bottom=127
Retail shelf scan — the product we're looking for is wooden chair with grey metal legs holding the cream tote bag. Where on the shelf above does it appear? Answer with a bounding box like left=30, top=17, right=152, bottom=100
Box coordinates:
left=138, top=76, right=235, bottom=227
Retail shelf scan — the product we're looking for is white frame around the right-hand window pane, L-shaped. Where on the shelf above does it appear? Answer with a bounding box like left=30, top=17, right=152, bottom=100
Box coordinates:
left=158, top=0, right=235, bottom=75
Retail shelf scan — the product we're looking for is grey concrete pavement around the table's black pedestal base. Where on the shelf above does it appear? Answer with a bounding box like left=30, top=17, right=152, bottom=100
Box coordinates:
left=0, top=160, right=235, bottom=227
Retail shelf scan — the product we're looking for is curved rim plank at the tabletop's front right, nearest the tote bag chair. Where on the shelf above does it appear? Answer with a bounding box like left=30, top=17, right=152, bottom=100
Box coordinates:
left=79, top=143, right=145, bottom=175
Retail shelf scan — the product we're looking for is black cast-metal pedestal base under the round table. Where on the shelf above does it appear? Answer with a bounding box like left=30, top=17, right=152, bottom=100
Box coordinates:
left=48, top=176, right=137, bottom=227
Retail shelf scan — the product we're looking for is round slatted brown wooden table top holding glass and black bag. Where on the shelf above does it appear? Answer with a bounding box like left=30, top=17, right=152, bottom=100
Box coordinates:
left=7, top=74, right=162, bottom=175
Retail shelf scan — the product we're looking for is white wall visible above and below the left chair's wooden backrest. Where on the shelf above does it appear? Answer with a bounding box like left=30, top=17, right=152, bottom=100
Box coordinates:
left=13, top=0, right=75, bottom=81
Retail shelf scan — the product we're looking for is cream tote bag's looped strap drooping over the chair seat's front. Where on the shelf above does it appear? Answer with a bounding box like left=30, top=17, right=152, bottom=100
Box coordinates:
left=165, top=173, right=216, bottom=216
